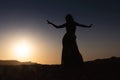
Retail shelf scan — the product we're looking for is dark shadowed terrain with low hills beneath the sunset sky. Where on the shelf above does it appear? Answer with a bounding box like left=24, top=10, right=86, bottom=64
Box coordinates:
left=0, top=57, right=120, bottom=80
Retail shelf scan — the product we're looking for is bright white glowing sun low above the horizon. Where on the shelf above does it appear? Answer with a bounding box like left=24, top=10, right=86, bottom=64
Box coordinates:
left=14, top=41, right=31, bottom=59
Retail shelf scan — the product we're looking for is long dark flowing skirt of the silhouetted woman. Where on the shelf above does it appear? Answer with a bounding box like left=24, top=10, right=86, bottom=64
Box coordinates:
left=62, top=33, right=83, bottom=66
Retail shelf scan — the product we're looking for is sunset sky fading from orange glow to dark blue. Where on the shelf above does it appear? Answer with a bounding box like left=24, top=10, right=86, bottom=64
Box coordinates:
left=0, top=0, right=120, bottom=64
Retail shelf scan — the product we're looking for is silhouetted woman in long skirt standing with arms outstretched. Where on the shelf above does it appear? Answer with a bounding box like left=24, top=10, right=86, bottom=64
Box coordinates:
left=47, top=14, right=92, bottom=66
